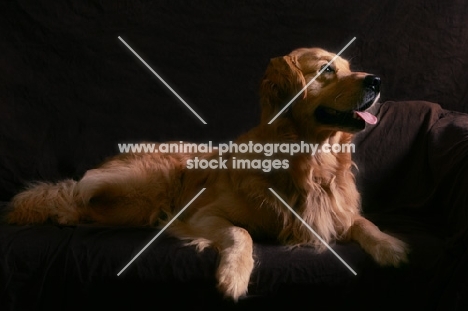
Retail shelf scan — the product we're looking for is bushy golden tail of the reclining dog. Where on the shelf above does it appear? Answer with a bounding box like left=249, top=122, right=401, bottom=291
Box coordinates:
left=6, top=179, right=80, bottom=225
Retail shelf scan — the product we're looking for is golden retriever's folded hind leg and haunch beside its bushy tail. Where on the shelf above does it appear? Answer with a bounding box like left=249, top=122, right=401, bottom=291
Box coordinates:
left=75, top=163, right=177, bottom=226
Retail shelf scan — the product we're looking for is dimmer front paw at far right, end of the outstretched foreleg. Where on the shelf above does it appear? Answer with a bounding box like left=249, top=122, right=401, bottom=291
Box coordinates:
left=370, top=234, right=409, bottom=267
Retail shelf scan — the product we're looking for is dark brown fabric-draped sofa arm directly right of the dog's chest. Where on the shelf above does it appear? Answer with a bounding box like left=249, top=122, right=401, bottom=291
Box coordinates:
left=353, top=101, right=446, bottom=214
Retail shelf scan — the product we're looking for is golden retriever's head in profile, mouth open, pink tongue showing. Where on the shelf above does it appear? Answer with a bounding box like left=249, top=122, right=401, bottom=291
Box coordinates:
left=260, top=48, right=380, bottom=133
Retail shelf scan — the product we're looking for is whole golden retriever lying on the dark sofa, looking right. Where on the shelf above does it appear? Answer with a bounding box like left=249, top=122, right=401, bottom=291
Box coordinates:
left=7, top=48, right=407, bottom=300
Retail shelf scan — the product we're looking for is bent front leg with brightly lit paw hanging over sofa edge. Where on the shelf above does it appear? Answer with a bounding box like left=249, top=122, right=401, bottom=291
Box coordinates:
left=169, top=215, right=254, bottom=301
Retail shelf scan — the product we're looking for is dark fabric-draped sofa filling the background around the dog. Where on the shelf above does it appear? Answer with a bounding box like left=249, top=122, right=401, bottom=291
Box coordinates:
left=0, top=0, right=468, bottom=310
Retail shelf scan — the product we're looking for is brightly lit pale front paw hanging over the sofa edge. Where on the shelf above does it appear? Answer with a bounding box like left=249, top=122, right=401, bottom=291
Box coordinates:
left=217, top=256, right=254, bottom=301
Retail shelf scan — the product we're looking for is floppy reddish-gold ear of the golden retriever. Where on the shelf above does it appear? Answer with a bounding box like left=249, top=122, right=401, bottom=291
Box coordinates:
left=260, top=56, right=307, bottom=123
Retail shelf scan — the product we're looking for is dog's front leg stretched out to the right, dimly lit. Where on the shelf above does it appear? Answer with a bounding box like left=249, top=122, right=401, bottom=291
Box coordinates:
left=348, top=217, right=408, bottom=267
